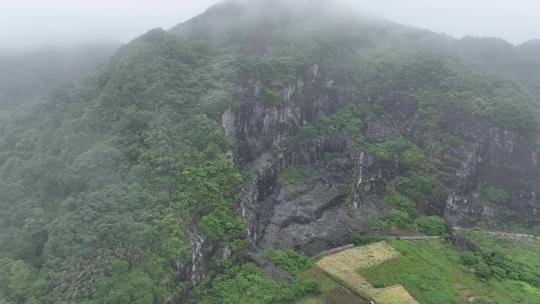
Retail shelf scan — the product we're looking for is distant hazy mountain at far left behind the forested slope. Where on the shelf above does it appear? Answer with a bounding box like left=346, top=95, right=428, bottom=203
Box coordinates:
left=0, top=42, right=120, bottom=107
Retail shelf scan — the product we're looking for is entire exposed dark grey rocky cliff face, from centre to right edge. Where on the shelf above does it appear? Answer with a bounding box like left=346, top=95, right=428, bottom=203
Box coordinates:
left=222, top=65, right=540, bottom=254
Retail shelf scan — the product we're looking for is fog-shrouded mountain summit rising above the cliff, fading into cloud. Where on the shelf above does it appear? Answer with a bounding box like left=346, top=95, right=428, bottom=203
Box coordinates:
left=170, top=0, right=390, bottom=47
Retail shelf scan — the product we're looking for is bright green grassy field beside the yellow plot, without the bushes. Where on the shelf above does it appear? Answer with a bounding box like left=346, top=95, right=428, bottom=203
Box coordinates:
left=360, top=241, right=540, bottom=304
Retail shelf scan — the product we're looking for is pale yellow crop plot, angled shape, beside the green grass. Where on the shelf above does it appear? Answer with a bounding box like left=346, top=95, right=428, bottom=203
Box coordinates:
left=317, top=242, right=418, bottom=304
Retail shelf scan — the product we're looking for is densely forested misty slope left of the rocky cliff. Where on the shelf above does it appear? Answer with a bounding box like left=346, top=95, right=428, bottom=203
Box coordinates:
left=0, top=31, right=249, bottom=304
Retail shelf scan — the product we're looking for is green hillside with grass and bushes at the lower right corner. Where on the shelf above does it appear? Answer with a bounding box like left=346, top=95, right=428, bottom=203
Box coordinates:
left=360, top=233, right=540, bottom=304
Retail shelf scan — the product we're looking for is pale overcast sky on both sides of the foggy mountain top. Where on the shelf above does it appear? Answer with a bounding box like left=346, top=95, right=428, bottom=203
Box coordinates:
left=0, top=0, right=540, bottom=51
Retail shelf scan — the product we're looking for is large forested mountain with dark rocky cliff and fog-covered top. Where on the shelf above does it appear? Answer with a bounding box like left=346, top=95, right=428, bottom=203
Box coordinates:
left=0, top=0, right=540, bottom=304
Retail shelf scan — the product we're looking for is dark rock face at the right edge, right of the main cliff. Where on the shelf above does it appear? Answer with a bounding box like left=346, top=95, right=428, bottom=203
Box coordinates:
left=444, top=126, right=540, bottom=226
